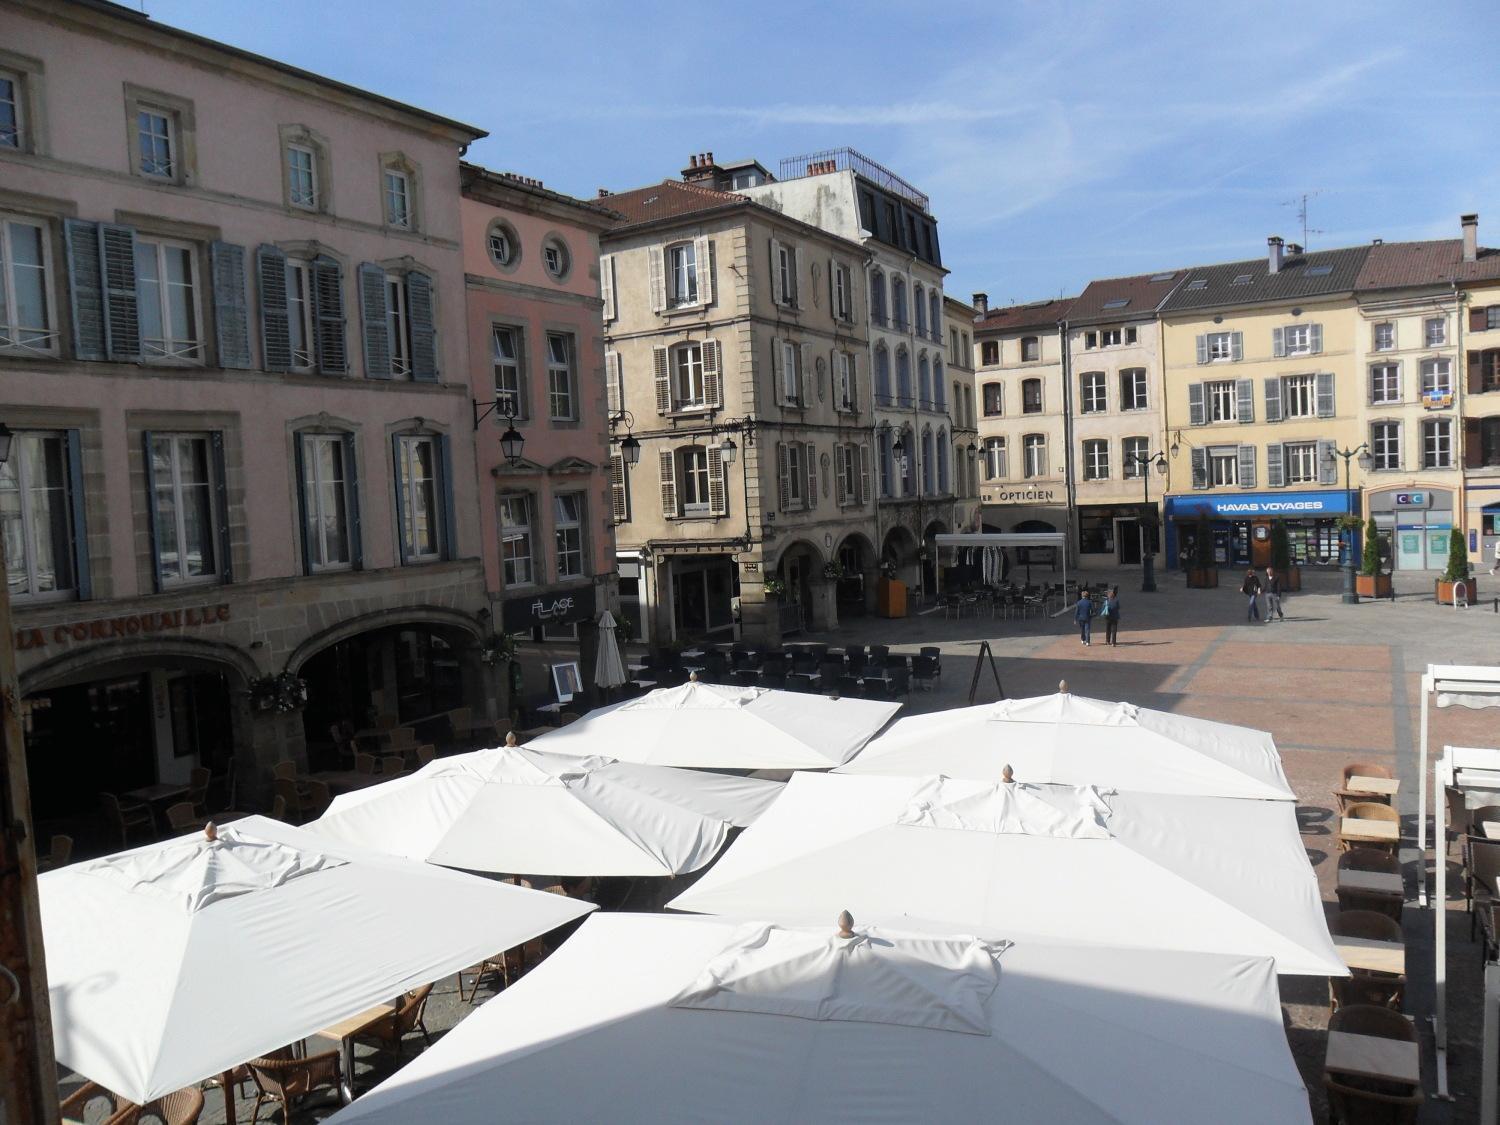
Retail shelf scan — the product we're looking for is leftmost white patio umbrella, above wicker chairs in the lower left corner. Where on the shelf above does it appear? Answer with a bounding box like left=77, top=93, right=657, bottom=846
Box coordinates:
left=38, top=816, right=594, bottom=1103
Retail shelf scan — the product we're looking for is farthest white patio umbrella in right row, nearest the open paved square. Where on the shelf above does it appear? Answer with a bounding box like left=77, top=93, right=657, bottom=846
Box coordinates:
left=839, top=692, right=1296, bottom=801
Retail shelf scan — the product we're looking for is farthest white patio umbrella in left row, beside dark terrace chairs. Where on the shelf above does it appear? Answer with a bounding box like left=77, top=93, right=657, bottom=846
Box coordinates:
left=530, top=681, right=900, bottom=770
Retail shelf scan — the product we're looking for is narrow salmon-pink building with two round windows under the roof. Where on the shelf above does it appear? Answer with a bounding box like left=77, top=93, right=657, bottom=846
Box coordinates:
left=461, top=165, right=621, bottom=716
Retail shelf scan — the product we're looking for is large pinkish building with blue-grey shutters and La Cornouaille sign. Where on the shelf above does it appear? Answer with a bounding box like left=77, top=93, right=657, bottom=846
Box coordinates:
left=0, top=0, right=495, bottom=831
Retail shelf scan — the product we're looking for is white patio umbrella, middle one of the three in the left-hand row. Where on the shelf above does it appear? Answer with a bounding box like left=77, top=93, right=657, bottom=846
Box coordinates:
left=308, top=750, right=782, bottom=876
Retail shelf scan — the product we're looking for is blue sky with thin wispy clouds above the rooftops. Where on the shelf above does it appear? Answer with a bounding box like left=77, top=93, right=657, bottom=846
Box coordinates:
left=143, top=0, right=1500, bottom=306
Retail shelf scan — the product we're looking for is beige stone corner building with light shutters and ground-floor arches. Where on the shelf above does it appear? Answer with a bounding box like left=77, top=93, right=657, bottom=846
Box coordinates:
left=600, top=155, right=878, bottom=644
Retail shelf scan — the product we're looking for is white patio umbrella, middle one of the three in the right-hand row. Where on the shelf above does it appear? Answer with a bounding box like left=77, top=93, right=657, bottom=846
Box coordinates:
left=668, top=774, right=1349, bottom=977
